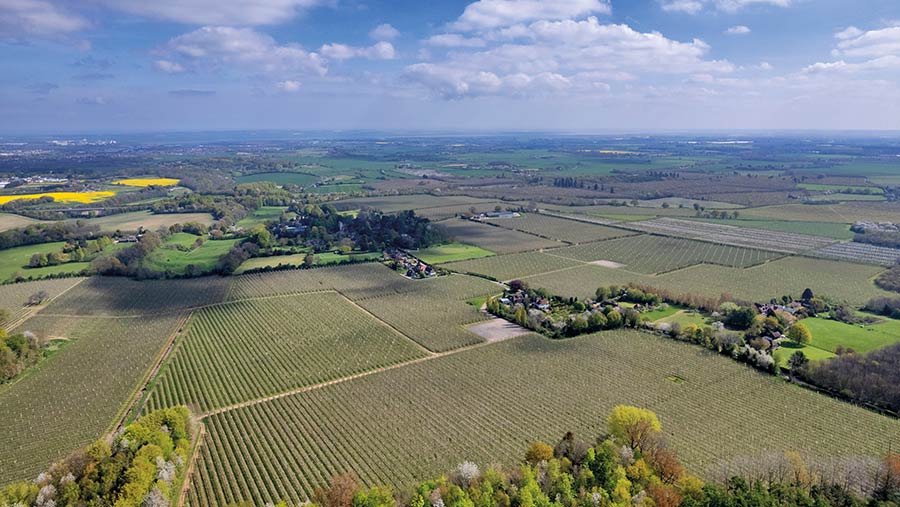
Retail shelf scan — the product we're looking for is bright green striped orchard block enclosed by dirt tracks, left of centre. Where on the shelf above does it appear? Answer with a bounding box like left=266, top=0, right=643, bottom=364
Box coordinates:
left=148, top=292, right=423, bottom=412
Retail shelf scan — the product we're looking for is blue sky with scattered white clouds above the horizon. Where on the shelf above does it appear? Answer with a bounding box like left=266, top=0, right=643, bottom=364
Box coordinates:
left=0, top=0, right=900, bottom=134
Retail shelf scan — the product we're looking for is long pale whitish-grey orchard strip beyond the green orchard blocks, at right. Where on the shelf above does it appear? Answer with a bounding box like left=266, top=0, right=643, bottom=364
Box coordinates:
left=621, top=218, right=834, bottom=253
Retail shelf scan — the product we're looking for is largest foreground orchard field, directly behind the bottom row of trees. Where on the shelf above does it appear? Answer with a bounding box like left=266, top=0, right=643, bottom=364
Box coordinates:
left=189, top=331, right=900, bottom=507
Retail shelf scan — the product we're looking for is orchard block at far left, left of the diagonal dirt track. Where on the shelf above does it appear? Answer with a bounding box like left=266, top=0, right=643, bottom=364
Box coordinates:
left=0, top=314, right=179, bottom=484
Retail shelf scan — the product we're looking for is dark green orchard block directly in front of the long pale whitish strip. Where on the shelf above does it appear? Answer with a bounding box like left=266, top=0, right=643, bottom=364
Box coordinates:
left=553, top=235, right=780, bottom=274
